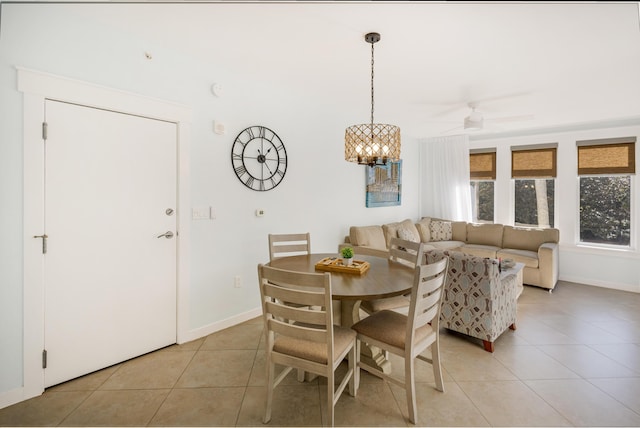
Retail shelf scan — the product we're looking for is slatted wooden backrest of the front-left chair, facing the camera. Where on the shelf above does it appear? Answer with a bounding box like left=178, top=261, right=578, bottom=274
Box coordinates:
left=258, top=264, right=333, bottom=364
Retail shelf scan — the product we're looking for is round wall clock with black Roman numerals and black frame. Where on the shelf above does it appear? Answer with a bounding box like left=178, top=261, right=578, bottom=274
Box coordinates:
left=231, top=126, right=287, bottom=192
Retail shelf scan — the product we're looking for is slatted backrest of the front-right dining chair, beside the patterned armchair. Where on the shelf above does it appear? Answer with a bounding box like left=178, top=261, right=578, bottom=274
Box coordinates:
left=407, top=257, right=449, bottom=352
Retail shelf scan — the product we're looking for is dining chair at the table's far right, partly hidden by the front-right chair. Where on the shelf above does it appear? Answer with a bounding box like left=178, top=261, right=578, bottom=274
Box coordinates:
left=360, top=238, right=425, bottom=315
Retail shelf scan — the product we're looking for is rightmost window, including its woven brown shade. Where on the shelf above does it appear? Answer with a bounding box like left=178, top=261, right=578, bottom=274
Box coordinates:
left=577, top=137, right=636, bottom=246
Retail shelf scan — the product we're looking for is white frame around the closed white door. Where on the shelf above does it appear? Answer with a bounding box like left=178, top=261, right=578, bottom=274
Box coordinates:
left=17, top=67, right=192, bottom=400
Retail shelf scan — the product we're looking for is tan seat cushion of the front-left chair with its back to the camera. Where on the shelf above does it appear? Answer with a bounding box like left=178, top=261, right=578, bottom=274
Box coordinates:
left=273, top=325, right=356, bottom=364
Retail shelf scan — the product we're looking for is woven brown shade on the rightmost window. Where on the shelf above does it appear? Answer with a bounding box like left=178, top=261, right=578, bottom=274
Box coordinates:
left=578, top=143, right=636, bottom=175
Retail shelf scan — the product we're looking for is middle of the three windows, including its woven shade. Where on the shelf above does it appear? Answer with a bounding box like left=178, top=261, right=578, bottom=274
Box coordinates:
left=511, top=144, right=557, bottom=228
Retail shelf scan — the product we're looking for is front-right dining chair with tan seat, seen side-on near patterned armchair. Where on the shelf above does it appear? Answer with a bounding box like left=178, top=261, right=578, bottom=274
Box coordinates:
left=351, top=257, right=449, bottom=424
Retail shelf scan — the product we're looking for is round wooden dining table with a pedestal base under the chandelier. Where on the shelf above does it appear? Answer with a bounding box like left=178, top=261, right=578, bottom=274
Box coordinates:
left=267, top=253, right=415, bottom=373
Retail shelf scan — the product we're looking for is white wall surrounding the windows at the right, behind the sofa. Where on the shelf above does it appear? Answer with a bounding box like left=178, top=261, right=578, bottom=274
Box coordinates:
left=470, top=119, right=640, bottom=292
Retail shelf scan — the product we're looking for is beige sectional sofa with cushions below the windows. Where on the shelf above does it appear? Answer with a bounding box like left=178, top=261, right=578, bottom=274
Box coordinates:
left=340, top=217, right=560, bottom=291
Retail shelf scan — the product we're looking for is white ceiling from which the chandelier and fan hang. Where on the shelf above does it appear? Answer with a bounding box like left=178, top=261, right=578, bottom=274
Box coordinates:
left=20, top=1, right=640, bottom=136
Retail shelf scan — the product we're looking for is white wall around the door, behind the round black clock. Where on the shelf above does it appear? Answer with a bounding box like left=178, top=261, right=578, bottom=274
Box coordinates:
left=0, top=4, right=418, bottom=407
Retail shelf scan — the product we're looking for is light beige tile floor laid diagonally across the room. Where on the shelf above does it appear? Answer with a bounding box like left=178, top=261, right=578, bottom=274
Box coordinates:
left=0, top=282, right=640, bottom=427
